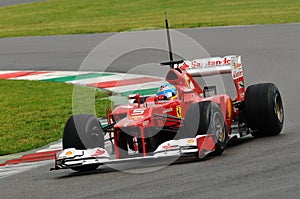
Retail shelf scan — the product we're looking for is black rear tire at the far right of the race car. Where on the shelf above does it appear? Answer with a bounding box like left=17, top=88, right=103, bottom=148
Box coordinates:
left=245, top=83, right=284, bottom=138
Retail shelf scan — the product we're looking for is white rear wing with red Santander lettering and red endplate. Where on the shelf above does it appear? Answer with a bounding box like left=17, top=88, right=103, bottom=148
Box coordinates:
left=178, top=55, right=245, bottom=101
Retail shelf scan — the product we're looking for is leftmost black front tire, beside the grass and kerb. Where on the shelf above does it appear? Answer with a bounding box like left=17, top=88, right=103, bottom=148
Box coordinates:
left=62, top=114, right=104, bottom=150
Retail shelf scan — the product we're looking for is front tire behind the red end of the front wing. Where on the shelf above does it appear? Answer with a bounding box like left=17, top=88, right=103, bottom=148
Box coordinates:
left=183, top=101, right=227, bottom=155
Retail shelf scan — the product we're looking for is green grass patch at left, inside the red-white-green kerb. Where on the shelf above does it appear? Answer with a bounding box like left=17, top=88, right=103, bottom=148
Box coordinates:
left=0, top=80, right=110, bottom=155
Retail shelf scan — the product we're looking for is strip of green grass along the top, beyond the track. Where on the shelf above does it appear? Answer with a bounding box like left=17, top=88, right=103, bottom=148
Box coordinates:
left=0, top=0, right=300, bottom=37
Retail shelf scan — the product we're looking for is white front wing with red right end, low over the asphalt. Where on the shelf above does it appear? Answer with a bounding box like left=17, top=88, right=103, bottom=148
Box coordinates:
left=51, top=134, right=215, bottom=170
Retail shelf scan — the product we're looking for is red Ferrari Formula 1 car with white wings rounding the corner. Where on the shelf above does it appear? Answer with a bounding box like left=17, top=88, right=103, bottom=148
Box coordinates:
left=53, top=21, right=284, bottom=171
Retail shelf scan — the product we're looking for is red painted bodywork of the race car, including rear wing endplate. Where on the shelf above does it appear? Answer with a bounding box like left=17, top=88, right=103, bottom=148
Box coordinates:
left=108, top=55, right=245, bottom=159
